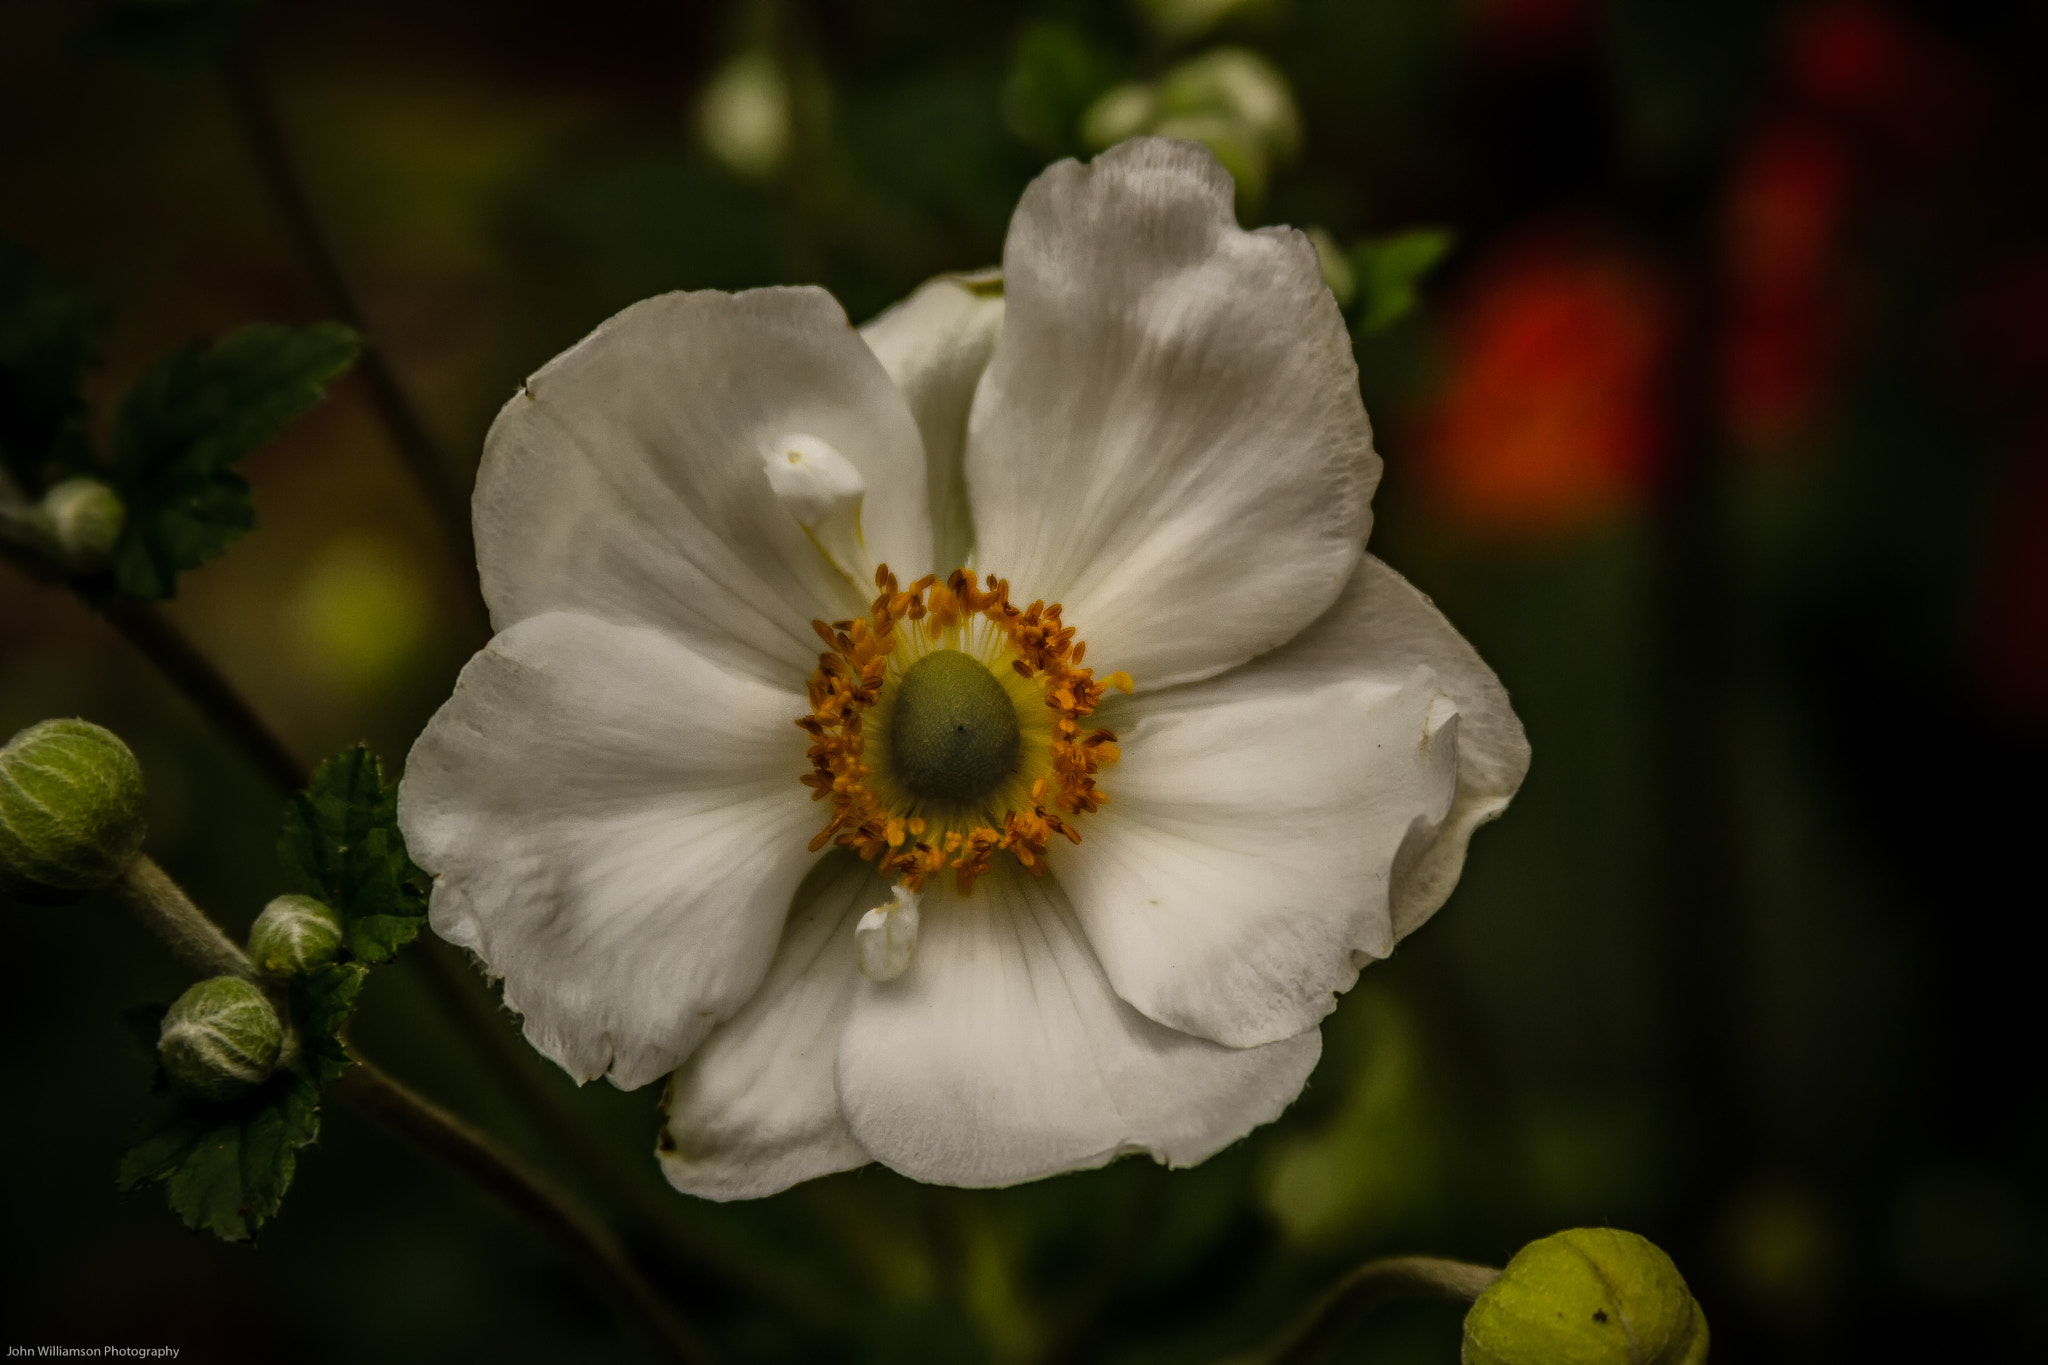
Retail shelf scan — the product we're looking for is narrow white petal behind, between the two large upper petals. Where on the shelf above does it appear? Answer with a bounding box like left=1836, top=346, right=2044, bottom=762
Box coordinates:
left=860, top=270, right=1004, bottom=581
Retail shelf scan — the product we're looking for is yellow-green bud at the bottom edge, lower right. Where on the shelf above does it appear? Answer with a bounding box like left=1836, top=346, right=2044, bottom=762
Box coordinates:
left=1460, top=1228, right=1706, bottom=1365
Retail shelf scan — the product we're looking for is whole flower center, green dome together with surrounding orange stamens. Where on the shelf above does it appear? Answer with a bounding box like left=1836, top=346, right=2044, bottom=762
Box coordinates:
left=797, top=565, right=1130, bottom=892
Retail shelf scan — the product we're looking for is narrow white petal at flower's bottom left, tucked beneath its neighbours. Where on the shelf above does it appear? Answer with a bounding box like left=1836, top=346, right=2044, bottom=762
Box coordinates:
left=659, top=853, right=889, bottom=1199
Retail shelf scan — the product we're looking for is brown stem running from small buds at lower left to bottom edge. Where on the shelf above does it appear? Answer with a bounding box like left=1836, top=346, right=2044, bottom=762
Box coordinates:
left=334, top=1050, right=717, bottom=1365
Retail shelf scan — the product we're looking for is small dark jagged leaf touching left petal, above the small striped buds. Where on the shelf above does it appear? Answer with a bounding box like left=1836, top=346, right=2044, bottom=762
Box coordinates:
left=279, top=745, right=426, bottom=962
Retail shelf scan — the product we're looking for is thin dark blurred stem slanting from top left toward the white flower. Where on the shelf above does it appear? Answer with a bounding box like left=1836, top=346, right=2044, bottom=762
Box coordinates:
left=221, top=43, right=475, bottom=571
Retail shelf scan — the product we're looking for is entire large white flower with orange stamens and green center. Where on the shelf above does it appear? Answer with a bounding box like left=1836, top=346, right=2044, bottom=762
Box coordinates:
left=399, top=139, right=1528, bottom=1199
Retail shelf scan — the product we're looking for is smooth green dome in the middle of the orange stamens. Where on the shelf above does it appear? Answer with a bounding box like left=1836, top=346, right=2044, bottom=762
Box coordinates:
left=889, top=649, right=1018, bottom=802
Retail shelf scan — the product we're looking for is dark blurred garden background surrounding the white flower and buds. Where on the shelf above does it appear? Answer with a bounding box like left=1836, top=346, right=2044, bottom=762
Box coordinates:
left=0, top=0, right=2048, bottom=1363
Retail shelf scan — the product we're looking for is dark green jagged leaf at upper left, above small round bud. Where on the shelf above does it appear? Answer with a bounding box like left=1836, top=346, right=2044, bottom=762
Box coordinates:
left=113, top=323, right=362, bottom=598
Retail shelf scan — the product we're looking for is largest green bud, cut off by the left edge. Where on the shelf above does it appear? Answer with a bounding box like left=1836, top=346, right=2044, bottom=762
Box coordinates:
left=0, top=720, right=145, bottom=905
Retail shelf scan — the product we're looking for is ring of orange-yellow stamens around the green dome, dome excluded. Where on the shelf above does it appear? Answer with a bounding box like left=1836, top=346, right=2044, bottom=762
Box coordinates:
left=797, top=565, right=1130, bottom=894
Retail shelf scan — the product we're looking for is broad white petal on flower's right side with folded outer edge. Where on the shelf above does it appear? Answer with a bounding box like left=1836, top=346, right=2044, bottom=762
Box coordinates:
left=1055, top=557, right=1528, bottom=1046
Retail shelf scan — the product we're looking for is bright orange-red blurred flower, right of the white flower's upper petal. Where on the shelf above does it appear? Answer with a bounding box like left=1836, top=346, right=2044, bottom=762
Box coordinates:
left=1417, top=235, right=1671, bottom=534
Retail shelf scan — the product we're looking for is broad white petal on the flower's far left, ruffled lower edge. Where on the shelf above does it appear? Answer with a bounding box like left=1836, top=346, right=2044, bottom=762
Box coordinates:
left=397, top=612, right=821, bottom=1089
